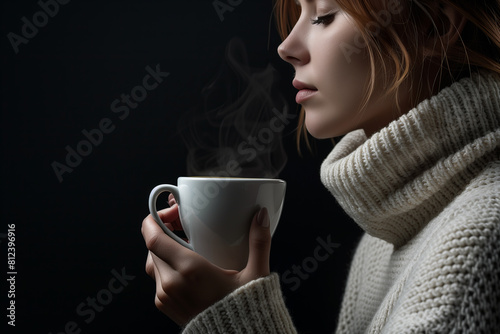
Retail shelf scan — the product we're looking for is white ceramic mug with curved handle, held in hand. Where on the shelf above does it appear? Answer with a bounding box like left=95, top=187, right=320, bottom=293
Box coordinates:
left=149, top=177, right=286, bottom=270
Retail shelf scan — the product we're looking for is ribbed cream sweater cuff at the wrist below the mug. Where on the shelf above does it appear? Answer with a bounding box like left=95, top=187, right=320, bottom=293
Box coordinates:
left=182, top=274, right=297, bottom=334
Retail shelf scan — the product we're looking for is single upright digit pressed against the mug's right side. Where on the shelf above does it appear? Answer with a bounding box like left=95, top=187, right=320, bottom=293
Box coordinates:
left=245, top=208, right=271, bottom=279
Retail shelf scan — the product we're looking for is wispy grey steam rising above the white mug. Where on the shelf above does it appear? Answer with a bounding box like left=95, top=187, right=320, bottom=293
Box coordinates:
left=179, top=39, right=296, bottom=178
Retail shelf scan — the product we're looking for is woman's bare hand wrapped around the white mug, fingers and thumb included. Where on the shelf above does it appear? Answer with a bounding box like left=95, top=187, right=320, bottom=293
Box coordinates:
left=142, top=205, right=271, bottom=326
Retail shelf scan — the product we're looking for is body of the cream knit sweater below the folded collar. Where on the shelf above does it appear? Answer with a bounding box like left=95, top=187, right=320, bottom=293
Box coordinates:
left=391, top=161, right=500, bottom=333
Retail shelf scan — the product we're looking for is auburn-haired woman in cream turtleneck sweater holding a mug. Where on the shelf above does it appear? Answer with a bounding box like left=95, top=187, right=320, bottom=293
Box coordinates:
left=142, top=0, right=500, bottom=333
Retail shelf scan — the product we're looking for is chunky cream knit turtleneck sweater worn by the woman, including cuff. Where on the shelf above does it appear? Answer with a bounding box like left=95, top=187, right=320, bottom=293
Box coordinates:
left=184, top=74, right=500, bottom=334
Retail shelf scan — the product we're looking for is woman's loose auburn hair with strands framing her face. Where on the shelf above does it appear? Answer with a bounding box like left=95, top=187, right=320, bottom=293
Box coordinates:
left=274, top=0, right=500, bottom=152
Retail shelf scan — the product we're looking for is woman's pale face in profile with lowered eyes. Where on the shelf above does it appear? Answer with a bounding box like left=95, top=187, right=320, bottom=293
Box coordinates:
left=278, top=0, right=408, bottom=138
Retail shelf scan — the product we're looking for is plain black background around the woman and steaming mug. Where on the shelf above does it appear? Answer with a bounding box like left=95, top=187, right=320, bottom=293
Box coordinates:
left=0, top=0, right=360, bottom=333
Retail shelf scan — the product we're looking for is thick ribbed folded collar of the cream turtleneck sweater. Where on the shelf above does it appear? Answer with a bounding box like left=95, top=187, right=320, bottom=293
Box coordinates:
left=321, top=73, right=500, bottom=247
